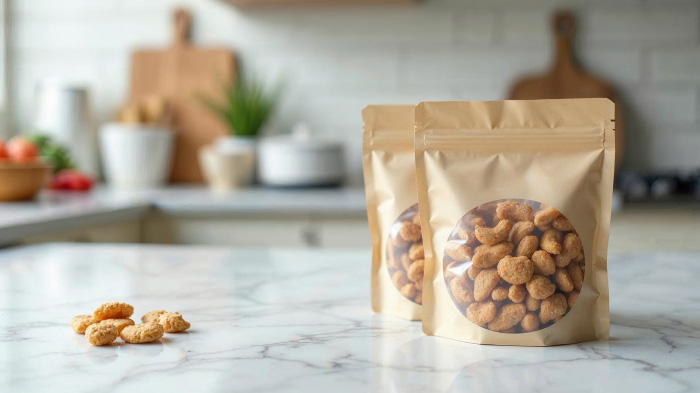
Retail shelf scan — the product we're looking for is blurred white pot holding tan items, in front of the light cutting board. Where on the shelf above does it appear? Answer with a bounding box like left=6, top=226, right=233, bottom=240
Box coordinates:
left=100, top=123, right=174, bottom=189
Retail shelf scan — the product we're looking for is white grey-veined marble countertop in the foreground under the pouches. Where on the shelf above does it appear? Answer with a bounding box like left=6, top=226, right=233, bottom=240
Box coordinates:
left=0, top=244, right=700, bottom=393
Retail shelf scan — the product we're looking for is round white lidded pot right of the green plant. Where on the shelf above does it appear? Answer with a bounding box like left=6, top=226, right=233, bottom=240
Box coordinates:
left=258, top=125, right=345, bottom=187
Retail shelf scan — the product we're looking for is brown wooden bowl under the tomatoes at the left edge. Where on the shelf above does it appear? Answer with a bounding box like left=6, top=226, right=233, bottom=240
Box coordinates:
left=0, top=162, right=51, bottom=202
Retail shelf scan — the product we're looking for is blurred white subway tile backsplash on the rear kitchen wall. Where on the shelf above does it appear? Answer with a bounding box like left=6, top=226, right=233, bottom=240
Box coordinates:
left=10, top=0, right=700, bottom=170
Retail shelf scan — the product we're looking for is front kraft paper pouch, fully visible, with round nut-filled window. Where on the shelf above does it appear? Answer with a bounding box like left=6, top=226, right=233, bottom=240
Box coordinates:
left=415, top=99, right=615, bottom=346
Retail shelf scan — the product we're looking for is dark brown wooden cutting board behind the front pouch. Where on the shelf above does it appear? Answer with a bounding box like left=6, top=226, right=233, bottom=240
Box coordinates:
left=509, top=12, right=625, bottom=166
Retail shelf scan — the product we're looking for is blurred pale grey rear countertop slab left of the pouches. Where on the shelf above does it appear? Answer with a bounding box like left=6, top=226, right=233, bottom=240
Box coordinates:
left=0, top=186, right=366, bottom=245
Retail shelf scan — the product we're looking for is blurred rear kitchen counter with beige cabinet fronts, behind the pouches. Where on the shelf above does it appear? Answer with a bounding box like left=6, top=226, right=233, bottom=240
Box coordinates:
left=0, top=186, right=700, bottom=248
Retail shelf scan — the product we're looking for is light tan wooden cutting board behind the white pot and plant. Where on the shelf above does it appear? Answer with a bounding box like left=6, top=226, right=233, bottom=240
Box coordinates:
left=129, top=9, right=236, bottom=183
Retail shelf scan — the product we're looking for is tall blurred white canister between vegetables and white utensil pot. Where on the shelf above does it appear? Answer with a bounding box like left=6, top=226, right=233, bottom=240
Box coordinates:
left=33, top=79, right=98, bottom=175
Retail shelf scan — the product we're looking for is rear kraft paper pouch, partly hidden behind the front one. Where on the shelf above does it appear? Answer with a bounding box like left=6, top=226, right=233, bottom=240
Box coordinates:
left=362, top=105, right=424, bottom=320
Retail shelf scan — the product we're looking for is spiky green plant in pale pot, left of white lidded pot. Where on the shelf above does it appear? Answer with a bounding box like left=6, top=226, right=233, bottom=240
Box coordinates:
left=199, top=73, right=280, bottom=190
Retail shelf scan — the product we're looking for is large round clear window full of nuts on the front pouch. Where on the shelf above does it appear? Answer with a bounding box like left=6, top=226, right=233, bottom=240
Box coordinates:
left=443, top=199, right=585, bottom=333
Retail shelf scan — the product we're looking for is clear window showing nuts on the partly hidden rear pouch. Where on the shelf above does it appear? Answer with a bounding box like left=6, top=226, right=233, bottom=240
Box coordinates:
left=386, top=204, right=425, bottom=304
